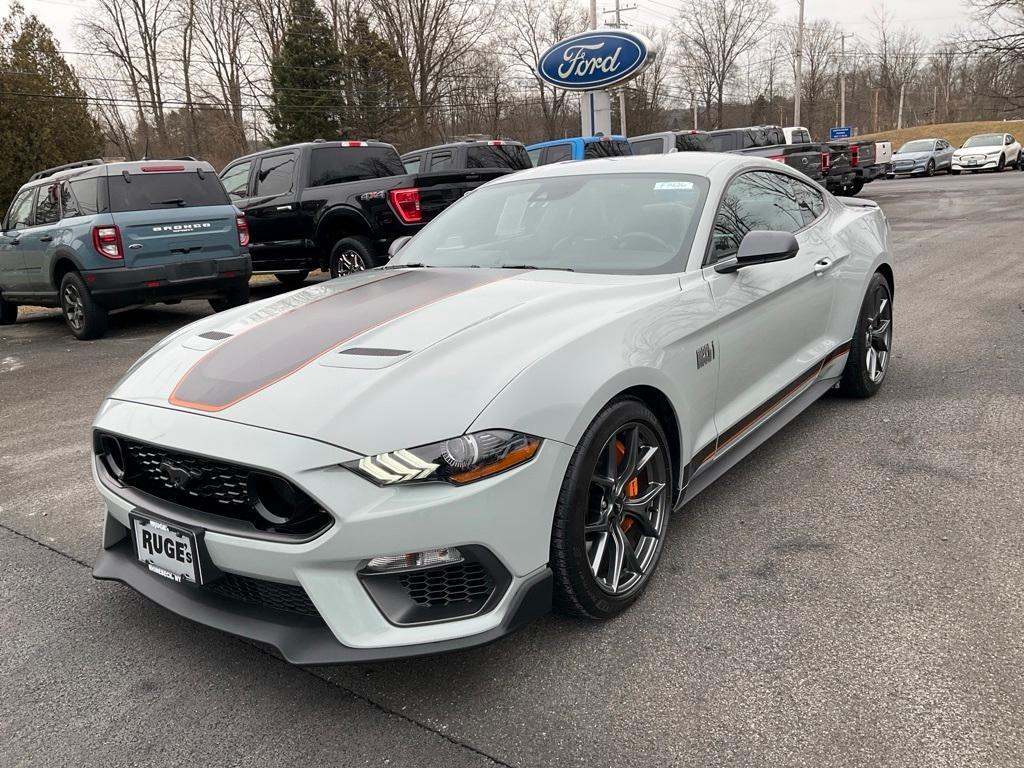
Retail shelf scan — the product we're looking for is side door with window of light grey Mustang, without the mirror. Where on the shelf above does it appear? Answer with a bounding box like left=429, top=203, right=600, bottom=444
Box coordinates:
left=702, top=171, right=842, bottom=452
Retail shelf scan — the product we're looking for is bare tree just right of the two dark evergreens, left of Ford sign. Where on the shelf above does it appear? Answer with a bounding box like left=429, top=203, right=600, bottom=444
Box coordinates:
left=370, top=0, right=493, bottom=136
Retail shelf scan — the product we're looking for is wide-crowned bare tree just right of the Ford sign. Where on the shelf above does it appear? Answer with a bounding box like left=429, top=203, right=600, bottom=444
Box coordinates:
left=676, top=0, right=774, bottom=127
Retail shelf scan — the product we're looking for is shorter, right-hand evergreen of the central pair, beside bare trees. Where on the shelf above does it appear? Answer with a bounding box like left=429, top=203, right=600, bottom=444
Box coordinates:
left=341, top=14, right=414, bottom=140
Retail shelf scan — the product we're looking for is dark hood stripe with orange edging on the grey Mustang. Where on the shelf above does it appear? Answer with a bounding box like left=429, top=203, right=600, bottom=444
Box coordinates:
left=169, top=269, right=517, bottom=412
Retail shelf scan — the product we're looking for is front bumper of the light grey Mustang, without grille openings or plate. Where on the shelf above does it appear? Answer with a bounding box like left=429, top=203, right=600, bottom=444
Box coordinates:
left=93, top=400, right=571, bottom=664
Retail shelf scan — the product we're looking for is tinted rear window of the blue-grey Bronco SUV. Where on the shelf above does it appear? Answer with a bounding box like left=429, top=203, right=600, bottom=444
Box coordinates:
left=108, top=171, right=229, bottom=212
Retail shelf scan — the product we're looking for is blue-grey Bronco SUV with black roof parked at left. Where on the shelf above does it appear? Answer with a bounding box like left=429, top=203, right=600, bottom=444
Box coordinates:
left=0, top=159, right=252, bottom=339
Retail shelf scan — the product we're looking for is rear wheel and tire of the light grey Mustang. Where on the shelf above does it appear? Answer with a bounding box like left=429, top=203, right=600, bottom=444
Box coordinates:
left=839, top=272, right=893, bottom=397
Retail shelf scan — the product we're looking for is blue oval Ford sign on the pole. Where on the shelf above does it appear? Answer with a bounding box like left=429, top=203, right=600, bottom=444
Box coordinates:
left=537, top=30, right=654, bottom=91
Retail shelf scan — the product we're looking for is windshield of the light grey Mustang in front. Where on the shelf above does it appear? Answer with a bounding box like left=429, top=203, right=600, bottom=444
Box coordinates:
left=390, top=173, right=708, bottom=274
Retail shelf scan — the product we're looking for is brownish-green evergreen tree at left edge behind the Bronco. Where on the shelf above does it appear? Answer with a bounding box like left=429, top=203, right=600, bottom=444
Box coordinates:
left=0, top=3, right=103, bottom=207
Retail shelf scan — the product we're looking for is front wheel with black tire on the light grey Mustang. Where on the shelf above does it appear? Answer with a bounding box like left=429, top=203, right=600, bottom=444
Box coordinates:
left=550, top=397, right=674, bottom=620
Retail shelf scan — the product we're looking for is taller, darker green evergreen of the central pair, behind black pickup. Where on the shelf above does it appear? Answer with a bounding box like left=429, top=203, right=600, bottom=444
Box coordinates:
left=269, top=0, right=341, bottom=144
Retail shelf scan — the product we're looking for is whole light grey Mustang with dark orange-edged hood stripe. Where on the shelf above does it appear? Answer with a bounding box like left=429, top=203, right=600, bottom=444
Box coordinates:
left=93, top=153, right=893, bottom=664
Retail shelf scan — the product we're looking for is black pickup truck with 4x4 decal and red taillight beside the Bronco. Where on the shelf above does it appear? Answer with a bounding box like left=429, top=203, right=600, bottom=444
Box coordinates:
left=220, top=140, right=509, bottom=285
